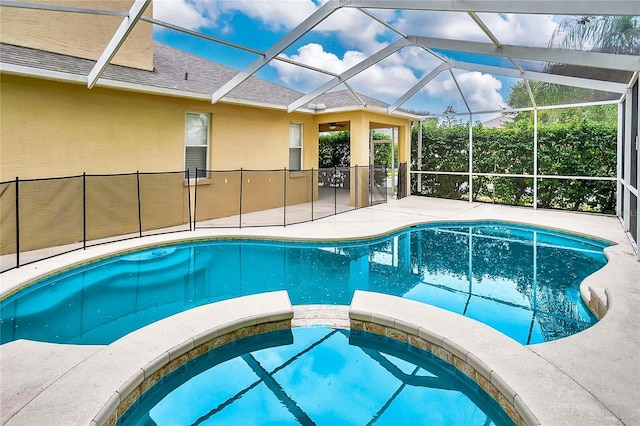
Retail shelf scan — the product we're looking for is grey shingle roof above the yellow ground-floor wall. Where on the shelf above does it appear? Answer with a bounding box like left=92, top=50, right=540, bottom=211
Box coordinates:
left=0, top=42, right=410, bottom=115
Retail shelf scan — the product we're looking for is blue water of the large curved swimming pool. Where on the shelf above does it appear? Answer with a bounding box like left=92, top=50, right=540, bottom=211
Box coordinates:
left=0, top=222, right=609, bottom=344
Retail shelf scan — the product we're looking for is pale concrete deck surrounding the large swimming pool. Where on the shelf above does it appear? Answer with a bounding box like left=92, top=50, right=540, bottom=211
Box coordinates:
left=0, top=197, right=640, bottom=425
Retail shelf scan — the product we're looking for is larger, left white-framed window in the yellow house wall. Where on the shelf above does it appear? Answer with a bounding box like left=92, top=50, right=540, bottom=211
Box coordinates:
left=184, top=112, right=209, bottom=178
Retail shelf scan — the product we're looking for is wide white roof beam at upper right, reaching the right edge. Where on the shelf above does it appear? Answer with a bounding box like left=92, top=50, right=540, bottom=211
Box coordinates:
left=416, top=37, right=640, bottom=71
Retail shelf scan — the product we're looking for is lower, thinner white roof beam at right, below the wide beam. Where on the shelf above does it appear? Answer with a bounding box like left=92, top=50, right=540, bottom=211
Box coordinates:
left=452, top=62, right=627, bottom=93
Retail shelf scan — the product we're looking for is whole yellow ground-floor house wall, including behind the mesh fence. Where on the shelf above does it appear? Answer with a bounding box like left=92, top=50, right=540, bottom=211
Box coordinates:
left=0, top=74, right=318, bottom=253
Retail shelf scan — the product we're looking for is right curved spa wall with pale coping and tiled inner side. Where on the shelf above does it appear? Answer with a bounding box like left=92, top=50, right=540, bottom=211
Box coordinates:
left=349, top=290, right=620, bottom=426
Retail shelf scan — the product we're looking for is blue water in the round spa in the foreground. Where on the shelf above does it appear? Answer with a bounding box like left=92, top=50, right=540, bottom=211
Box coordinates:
left=118, top=327, right=513, bottom=426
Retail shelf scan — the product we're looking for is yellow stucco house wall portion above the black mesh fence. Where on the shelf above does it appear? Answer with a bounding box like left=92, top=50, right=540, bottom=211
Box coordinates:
left=0, top=74, right=318, bottom=181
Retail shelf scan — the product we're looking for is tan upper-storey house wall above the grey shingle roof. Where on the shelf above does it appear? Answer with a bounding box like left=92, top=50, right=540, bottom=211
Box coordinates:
left=0, top=0, right=153, bottom=71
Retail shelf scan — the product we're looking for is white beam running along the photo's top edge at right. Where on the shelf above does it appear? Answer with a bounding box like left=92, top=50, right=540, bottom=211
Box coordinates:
left=347, top=0, right=638, bottom=16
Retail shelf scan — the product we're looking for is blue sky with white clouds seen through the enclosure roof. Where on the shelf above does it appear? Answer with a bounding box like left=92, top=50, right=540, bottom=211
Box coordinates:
left=153, top=0, right=560, bottom=113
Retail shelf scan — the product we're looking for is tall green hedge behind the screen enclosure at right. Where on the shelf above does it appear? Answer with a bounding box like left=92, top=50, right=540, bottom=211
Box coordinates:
left=411, top=119, right=617, bottom=214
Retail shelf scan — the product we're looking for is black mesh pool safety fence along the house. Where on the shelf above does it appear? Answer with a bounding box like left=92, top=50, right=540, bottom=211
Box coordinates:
left=0, top=166, right=388, bottom=272
